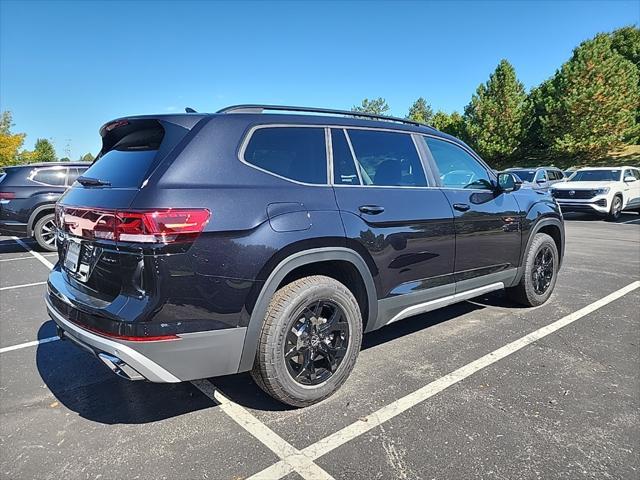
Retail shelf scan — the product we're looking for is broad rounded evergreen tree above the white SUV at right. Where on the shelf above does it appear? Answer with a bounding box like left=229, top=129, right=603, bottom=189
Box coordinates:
left=537, top=34, right=640, bottom=160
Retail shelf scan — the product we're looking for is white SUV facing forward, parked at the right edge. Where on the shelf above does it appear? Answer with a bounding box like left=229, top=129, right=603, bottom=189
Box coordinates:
left=552, top=167, right=640, bottom=220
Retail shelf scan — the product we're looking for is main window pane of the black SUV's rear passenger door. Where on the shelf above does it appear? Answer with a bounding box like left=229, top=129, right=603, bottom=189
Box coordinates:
left=348, top=130, right=427, bottom=187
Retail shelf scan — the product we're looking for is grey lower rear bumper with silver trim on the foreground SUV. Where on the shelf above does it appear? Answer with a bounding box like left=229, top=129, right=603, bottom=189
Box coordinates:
left=45, top=297, right=246, bottom=383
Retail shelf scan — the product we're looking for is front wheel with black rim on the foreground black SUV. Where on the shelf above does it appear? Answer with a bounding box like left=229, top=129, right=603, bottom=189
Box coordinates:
left=507, top=233, right=560, bottom=307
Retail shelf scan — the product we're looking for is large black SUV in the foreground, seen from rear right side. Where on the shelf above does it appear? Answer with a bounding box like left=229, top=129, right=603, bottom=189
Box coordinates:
left=46, top=105, right=564, bottom=406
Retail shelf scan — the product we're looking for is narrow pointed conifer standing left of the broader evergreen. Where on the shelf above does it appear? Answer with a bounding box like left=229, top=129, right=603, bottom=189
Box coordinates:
left=464, top=60, right=529, bottom=163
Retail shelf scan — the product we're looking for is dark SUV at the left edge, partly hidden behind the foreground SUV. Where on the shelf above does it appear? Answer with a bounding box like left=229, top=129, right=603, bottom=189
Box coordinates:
left=0, top=162, right=90, bottom=251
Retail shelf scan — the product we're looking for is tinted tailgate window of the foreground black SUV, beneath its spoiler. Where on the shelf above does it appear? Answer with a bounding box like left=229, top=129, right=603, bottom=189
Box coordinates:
left=80, top=128, right=164, bottom=188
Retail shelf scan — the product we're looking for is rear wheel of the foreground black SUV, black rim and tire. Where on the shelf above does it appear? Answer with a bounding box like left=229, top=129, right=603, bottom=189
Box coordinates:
left=251, top=275, right=362, bottom=407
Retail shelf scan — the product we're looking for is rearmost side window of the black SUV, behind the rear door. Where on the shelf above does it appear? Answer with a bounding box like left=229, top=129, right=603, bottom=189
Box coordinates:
left=244, top=127, right=327, bottom=184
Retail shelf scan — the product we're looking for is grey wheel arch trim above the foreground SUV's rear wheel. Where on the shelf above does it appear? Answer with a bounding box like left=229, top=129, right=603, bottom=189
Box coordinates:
left=238, top=247, right=378, bottom=372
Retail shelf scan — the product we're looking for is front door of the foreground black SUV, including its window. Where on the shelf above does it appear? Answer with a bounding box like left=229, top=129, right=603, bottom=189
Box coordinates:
left=422, top=137, right=520, bottom=292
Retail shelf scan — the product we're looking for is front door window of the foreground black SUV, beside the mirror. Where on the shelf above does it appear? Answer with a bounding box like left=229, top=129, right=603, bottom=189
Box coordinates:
left=423, top=137, right=491, bottom=189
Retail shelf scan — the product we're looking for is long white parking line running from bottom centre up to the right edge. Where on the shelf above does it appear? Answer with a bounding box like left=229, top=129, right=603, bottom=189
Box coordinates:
left=249, top=281, right=640, bottom=480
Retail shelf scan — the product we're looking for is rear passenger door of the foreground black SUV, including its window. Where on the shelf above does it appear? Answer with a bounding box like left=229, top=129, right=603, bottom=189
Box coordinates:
left=330, top=128, right=455, bottom=329
